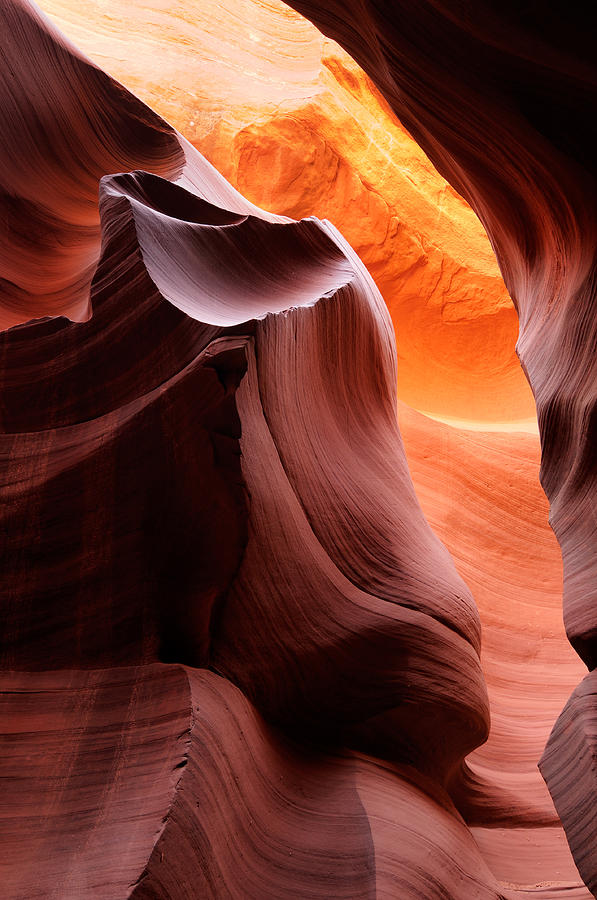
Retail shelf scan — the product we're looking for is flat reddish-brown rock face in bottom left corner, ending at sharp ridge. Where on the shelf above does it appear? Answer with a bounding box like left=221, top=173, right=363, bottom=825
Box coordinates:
left=0, top=666, right=193, bottom=900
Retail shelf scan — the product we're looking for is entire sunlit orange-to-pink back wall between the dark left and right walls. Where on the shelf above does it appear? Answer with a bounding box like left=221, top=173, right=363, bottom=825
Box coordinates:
left=3, top=0, right=590, bottom=900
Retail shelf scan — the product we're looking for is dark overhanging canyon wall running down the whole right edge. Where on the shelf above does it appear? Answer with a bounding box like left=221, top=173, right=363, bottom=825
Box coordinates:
left=282, top=0, right=597, bottom=890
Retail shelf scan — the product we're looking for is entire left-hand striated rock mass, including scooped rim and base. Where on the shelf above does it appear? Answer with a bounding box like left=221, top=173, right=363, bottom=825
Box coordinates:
left=0, top=0, right=506, bottom=900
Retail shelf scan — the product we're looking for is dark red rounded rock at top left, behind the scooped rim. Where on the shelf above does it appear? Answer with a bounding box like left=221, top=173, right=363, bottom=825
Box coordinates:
left=0, top=3, right=184, bottom=327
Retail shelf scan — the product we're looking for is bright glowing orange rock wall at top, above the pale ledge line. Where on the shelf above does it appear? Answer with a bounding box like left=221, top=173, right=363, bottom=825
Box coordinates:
left=42, top=0, right=534, bottom=422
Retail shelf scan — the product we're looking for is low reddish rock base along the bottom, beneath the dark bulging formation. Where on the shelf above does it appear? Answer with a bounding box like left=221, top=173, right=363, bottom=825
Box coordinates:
left=0, top=665, right=502, bottom=900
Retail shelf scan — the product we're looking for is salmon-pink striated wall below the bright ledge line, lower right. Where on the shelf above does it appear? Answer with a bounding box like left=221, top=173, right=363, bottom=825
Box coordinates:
left=399, top=405, right=589, bottom=897
